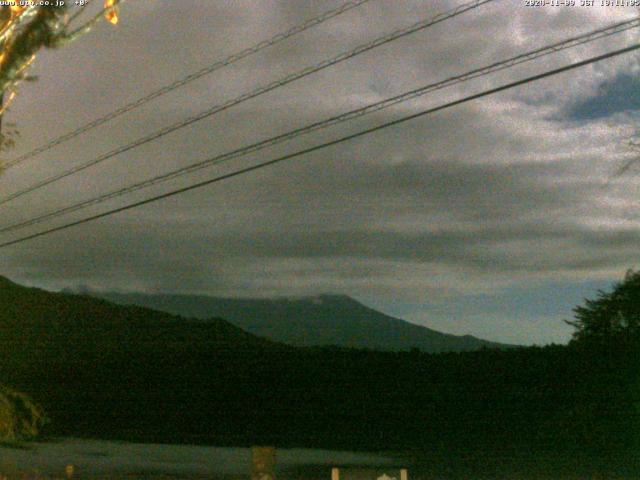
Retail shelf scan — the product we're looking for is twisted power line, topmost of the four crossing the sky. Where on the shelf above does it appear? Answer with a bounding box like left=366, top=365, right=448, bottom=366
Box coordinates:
left=4, top=0, right=370, bottom=169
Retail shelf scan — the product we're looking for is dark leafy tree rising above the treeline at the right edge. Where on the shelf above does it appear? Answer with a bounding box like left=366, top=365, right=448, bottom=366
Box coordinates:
left=565, top=270, right=640, bottom=343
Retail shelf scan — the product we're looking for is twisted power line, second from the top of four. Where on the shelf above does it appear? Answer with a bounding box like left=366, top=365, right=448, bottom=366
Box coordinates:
left=0, top=0, right=495, bottom=205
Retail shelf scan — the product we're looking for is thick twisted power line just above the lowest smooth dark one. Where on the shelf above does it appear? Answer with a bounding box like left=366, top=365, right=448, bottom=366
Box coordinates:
left=0, top=17, right=640, bottom=233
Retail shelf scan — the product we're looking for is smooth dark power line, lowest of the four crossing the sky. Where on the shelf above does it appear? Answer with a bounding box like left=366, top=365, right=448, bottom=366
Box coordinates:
left=0, top=43, right=640, bottom=248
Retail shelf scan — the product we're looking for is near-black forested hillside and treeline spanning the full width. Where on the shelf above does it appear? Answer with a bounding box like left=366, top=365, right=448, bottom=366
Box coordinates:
left=0, top=274, right=640, bottom=478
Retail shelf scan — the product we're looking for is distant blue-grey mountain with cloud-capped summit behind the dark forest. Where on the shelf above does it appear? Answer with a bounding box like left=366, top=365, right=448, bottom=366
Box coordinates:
left=94, top=293, right=507, bottom=353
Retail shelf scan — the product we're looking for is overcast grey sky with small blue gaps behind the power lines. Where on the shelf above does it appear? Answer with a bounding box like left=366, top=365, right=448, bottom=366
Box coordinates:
left=0, top=0, right=640, bottom=344
